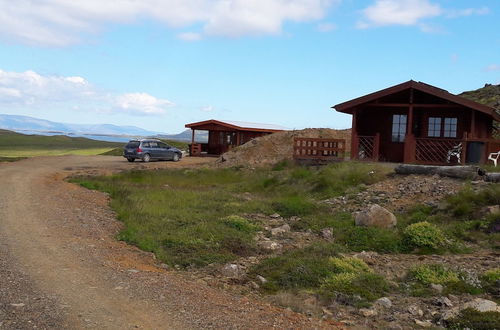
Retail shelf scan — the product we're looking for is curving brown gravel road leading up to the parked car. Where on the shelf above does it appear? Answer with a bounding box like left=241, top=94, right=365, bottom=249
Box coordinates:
left=0, top=156, right=333, bottom=329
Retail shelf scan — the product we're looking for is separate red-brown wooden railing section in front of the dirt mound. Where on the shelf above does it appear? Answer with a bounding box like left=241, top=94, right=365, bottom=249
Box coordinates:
left=293, top=138, right=346, bottom=160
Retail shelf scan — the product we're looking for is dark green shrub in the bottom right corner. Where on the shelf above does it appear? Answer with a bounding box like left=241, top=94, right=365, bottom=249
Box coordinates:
left=445, top=308, right=500, bottom=330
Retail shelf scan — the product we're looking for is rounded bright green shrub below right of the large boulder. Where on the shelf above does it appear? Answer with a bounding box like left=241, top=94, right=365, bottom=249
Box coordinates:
left=403, top=221, right=446, bottom=250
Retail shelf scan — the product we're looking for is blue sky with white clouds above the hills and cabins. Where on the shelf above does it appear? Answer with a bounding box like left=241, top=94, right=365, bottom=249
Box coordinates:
left=0, top=0, right=500, bottom=133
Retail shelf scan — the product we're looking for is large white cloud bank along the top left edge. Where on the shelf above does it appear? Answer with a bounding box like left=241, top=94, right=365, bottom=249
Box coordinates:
left=0, top=0, right=341, bottom=46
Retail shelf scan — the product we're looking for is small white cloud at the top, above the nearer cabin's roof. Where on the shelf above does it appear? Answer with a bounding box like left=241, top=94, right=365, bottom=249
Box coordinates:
left=358, top=0, right=442, bottom=28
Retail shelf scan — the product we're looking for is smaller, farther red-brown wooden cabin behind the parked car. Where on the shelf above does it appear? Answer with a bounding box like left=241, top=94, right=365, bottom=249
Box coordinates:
left=186, top=119, right=286, bottom=156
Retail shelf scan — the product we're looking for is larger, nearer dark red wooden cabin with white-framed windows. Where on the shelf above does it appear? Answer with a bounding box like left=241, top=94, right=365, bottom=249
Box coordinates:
left=333, top=80, right=500, bottom=165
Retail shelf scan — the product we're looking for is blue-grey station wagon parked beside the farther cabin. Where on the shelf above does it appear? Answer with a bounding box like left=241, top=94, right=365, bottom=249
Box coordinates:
left=123, top=139, right=182, bottom=163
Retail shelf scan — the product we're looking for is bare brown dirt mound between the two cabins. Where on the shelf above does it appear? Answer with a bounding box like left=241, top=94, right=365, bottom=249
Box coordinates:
left=217, top=128, right=351, bottom=167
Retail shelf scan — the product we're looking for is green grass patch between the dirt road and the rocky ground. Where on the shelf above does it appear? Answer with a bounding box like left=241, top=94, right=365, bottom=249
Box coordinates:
left=71, top=163, right=388, bottom=267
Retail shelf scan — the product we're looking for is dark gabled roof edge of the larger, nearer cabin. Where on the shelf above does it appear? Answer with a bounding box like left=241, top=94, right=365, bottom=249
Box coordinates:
left=332, top=80, right=500, bottom=121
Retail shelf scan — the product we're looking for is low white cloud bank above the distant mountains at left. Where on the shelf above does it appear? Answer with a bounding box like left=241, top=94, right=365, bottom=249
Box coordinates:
left=0, top=70, right=173, bottom=115
